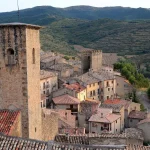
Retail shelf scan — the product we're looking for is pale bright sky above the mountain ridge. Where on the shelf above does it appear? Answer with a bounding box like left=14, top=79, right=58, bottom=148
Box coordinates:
left=0, top=0, right=150, bottom=12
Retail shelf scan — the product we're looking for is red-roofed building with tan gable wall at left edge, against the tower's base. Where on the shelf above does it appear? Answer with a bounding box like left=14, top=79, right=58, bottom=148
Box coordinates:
left=0, top=110, right=22, bottom=137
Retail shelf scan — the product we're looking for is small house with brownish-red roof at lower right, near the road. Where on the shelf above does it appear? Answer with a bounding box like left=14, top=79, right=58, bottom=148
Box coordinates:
left=128, top=110, right=147, bottom=128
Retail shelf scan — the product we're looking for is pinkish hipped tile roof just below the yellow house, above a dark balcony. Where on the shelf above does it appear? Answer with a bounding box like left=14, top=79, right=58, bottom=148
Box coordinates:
left=53, top=94, right=80, bottom=105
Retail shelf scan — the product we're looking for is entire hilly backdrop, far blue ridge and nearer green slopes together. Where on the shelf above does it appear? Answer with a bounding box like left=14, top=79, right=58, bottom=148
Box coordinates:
left=0, top=6, right=150, bottom=55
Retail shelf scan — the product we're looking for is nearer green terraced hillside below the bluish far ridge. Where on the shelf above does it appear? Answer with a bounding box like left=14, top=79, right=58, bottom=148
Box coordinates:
left=41, top=19, right=150, bottom=55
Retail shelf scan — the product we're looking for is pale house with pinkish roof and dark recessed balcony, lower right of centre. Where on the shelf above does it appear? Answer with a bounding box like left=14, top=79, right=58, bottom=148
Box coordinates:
left=89, top=108, right=121, bottom=134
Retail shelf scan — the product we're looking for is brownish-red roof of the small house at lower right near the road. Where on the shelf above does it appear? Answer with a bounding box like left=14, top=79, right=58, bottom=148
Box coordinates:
left=128, top=110, right=146, bottom=119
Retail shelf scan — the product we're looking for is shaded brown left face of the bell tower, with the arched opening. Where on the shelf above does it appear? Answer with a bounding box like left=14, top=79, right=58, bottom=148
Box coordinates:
left=0, top=26, right=29, bottom=138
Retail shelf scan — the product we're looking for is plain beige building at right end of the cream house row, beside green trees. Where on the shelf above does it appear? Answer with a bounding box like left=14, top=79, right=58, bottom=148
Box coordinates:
left=115, top=75, right=133, bottom=98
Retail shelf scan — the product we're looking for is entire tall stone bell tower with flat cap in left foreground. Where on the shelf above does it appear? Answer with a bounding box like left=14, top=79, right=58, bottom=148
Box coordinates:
left=0, top=23, right=42, bottom=140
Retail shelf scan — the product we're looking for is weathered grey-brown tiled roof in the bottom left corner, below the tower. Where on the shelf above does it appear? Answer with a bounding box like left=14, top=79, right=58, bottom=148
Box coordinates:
left=0, top=135, right=48, bottom=150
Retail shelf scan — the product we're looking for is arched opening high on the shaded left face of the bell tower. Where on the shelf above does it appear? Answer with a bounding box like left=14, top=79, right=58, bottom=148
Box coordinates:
left=7, top=48, right=15, bottom=65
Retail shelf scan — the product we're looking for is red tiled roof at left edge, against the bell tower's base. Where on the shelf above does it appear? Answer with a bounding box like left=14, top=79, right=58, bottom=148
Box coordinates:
left=0, top=110, right=20, bottom=135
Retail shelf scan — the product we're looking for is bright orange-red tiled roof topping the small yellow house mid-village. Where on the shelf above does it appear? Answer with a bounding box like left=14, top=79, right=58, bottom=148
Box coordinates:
left=64, top=83, right=86, bottom=92
